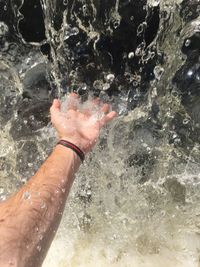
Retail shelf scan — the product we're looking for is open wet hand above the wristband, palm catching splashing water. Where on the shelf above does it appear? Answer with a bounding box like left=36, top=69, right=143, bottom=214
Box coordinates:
left=50, top=93, right=117, bottom=153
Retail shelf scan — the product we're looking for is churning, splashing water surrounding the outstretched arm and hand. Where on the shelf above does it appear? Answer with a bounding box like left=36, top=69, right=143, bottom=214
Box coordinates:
left=0, top=0, right=200, bottom=267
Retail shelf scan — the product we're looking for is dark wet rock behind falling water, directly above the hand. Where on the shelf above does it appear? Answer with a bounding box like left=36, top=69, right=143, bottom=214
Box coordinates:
left=40, top=0, right=159, bottom=104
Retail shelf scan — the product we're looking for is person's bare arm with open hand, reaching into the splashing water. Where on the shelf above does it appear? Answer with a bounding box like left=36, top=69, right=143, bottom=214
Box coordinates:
left=0, top=94, right=116, bottom=267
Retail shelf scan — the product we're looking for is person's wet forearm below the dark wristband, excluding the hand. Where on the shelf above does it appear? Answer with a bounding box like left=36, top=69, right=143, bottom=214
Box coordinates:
left=0, top=146, right=80, bottom=267
